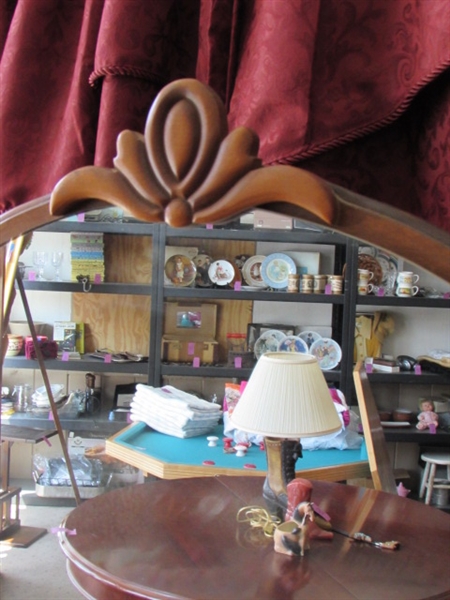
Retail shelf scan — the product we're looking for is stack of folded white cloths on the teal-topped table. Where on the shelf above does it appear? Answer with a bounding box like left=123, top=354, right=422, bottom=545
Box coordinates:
left=130, top=383, right=222, bottom=438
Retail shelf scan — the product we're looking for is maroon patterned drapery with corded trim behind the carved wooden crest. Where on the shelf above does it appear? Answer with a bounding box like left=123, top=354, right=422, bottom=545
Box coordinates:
left=0, top=0, right=450, bottom=231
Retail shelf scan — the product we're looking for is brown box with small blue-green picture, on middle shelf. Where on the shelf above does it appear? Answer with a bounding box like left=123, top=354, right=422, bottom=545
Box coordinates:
left=161, top=302, right=219, bottom=364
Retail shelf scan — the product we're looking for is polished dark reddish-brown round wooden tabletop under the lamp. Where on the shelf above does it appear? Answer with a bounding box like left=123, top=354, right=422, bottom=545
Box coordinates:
left=60, top=476, right=450, bottom=600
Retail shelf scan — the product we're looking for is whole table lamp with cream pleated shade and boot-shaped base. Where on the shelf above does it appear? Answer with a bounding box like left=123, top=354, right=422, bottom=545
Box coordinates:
left=230, top=352, right=342, bottom=516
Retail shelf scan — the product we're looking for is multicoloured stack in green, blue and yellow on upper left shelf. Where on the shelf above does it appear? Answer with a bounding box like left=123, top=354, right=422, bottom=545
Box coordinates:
left=70, top=233, right=105, bottom=283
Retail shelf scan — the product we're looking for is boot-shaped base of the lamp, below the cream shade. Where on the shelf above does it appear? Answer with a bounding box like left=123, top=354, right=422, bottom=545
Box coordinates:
left=263, top=438, right=302, bottom=519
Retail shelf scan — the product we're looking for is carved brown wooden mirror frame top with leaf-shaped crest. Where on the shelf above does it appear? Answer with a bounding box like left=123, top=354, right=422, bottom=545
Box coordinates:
left=0, top=79, right=450, bottom=281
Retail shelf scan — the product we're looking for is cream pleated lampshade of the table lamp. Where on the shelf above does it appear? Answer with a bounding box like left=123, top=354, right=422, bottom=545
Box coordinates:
left=230, top=352, right=342, bottom=438
